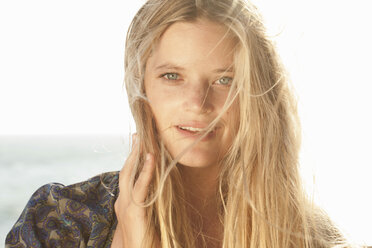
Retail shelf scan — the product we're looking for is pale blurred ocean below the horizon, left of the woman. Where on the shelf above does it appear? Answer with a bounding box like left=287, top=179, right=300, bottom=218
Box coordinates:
left=0, top=135, right=129, bottom=247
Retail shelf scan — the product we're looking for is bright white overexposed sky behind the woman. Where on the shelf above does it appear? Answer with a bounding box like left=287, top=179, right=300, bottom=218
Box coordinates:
left=0, top=0, right=372, bottom=245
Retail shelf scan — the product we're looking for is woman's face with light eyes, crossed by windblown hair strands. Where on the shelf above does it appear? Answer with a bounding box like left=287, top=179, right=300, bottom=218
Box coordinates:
left=145, top=20, right=237, bottom=167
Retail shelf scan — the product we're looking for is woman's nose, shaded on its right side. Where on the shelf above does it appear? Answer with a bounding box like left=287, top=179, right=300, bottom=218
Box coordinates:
left=183, top=81, right=213, bottom=114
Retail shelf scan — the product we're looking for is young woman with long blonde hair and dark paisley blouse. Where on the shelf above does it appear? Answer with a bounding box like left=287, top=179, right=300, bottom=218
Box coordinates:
left=6, top=0, right=352, bottom=248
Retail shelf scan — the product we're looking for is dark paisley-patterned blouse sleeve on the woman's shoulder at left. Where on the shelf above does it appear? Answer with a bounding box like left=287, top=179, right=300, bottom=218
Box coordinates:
left=5, top=172, right=119, bottom=248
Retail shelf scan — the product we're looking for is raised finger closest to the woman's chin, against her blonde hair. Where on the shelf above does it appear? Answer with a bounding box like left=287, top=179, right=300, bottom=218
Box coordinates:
left=133, top=153, right=155, bottom=203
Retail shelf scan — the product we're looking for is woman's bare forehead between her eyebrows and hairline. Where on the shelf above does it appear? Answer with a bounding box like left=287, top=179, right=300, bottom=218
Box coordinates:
left=149, top=20, right=234, bottom=70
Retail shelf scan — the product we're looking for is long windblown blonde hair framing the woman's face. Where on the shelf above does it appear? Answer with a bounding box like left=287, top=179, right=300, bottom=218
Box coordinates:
left=125, top=0, right=344, bottom=248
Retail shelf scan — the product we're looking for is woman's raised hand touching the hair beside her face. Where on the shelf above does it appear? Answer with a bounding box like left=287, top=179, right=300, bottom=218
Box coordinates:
left=111, top=134, right=155, bottom=248
